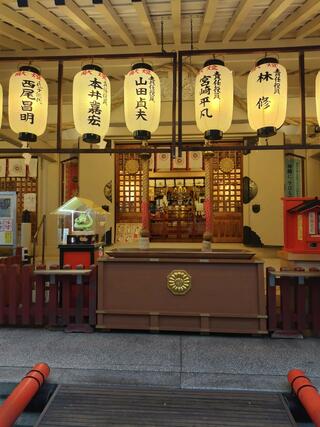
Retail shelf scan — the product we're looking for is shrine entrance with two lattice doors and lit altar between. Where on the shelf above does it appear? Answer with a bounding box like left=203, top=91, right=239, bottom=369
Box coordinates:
left=115, top=145, right=243, bottom=243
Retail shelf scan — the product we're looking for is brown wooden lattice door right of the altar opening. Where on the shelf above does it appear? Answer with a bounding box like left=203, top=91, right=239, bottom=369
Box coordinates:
left=212, top=151, right=243, bottom=243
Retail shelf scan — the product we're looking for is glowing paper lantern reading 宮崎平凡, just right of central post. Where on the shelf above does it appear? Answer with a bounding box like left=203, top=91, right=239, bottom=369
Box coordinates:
left=195, top=59, right=233, bottom=140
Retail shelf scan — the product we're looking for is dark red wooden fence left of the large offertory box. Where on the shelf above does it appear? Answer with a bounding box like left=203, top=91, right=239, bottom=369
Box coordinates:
left=0, top=264, right=97, bottom=331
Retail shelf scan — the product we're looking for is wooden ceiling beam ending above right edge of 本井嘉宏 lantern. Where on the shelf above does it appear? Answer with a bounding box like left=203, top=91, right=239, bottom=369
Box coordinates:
left=55, top=0, right=111, bottom=46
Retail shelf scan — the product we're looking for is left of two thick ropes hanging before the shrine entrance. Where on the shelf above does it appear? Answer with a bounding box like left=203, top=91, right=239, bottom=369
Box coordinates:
left=140, top=142, right=151, bottom=249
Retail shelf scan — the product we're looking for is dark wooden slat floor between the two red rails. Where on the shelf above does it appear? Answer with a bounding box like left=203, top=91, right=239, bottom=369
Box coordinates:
left=36, top=385, right=296, bottom=427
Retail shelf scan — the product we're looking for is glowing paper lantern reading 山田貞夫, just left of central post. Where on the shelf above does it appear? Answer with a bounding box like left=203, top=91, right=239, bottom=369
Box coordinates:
left=124, top=63, right=161, bottom=140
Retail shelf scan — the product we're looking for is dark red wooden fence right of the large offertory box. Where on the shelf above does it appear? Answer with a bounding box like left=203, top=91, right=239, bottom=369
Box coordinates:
left=267, top=268, right=320, bottom=337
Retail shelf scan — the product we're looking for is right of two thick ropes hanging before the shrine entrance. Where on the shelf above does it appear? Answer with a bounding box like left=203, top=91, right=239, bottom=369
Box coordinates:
left=202, top=142, right=213, bottom=251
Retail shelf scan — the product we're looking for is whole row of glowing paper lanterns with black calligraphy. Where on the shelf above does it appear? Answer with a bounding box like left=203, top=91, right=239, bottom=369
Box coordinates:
left=0, top=57, right=320, bottom=144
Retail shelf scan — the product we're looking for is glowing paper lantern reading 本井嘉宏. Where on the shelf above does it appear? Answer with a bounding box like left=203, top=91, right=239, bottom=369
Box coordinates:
left=72, top=64, right=111, bottom=144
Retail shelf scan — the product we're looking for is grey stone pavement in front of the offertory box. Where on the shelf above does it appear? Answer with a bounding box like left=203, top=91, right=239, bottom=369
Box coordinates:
left=0, top=328, right=320, bottom=391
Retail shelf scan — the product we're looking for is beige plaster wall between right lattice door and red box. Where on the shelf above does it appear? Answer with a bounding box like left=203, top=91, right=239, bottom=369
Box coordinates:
left=243, top=133, right=284, bottom=246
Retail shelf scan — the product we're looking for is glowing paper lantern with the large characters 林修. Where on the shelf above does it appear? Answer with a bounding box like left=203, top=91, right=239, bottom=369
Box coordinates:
left=247, top=58, right=288, bottom=137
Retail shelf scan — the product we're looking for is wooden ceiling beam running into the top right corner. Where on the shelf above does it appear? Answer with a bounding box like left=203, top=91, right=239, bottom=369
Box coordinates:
left=271, top=0, right=320, bottom=40
